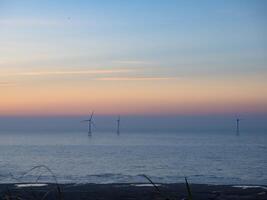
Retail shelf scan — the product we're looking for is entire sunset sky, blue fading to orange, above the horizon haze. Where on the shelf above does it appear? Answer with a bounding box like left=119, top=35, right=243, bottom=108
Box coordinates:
left=0, top=0, right=267, bottom=119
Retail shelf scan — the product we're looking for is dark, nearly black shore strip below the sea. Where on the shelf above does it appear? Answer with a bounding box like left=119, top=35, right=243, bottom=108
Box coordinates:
left=0, top=183, right=267, bottom=200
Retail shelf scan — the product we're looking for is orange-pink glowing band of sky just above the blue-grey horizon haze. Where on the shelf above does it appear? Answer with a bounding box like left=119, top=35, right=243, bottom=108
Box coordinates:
left=0, top=74, right=267, bottom=115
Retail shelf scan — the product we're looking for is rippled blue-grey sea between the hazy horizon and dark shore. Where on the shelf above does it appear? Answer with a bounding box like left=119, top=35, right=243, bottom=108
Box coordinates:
left=0, top=132, right=267, bottom=185
